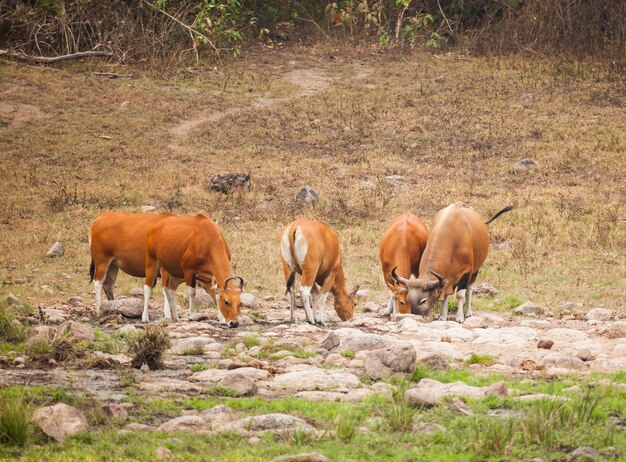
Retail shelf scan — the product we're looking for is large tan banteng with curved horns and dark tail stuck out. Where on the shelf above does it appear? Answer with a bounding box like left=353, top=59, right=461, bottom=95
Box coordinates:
left=391, top=204, right=513, bottom=323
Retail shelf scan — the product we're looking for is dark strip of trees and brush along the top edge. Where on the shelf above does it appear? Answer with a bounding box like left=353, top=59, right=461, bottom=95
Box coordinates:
left=0, top=0, right=626, bottom=65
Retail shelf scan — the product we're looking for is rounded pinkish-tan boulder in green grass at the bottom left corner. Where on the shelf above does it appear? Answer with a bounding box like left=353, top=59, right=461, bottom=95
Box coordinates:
left=33, top=403, right=89, bottom=443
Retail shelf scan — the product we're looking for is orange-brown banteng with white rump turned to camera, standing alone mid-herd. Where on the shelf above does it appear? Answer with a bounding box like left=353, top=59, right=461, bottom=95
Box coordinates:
left=280, top=218, right=359, bottom=325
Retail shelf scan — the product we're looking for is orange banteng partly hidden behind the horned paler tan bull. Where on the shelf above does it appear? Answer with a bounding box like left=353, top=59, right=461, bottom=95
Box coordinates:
left=380, top=212, right=428, bottom=316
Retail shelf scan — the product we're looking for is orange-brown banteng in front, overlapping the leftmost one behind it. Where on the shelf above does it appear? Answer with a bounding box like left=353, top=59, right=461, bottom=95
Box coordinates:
left=142, top=215, right=243, bottom=327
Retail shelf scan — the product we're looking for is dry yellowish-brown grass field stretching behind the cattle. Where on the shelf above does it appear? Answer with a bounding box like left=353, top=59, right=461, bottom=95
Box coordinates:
left=0, top=47, right=626, bottom=310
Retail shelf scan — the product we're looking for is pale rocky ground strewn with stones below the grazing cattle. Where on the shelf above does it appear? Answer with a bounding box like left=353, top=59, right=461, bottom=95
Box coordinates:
left=0, top=293, right=626, bottom=452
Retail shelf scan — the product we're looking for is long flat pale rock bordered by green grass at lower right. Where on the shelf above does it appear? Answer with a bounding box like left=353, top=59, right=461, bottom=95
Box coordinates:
left=404, top=379, right=508, bottom=406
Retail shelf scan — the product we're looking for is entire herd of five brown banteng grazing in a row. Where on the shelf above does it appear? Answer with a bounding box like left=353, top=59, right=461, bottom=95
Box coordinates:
left=89, top=203, right=512, bottom=327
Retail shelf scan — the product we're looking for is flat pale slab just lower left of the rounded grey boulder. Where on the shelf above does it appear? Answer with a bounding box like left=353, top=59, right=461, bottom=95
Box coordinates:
left=271, top=364, right=361, bottom=392
